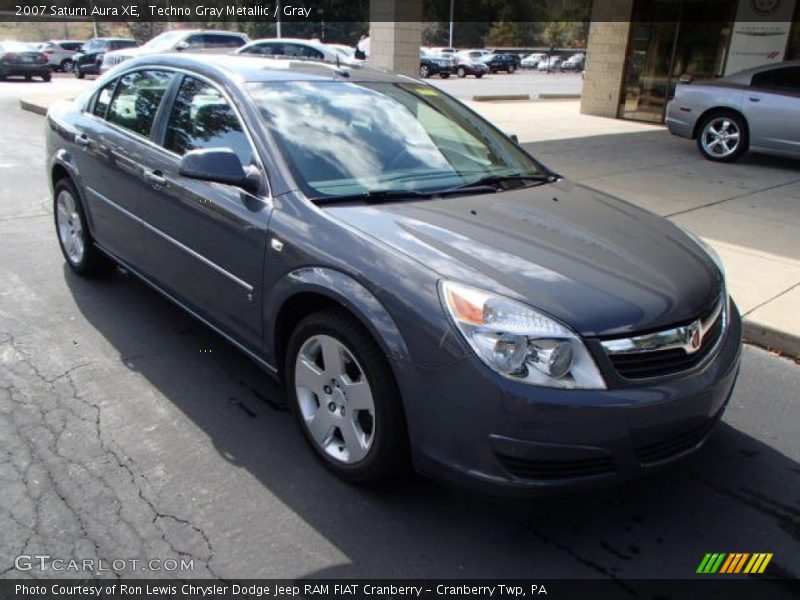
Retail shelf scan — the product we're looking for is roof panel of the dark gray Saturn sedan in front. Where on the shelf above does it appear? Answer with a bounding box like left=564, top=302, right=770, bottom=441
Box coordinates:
left=119, top=52, right=416, bottom=83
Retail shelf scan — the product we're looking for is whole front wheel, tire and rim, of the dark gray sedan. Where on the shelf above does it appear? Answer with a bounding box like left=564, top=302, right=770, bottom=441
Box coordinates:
left=285, top=309, right=408, bottom=483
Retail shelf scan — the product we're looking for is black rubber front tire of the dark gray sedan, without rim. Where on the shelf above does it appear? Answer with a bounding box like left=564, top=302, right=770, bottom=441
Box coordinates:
left=284, top=309, right=410, bottom=483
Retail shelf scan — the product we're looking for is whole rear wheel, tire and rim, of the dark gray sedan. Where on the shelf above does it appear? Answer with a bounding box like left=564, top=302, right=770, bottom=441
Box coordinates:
left=53, top=179, right=114, bottom=277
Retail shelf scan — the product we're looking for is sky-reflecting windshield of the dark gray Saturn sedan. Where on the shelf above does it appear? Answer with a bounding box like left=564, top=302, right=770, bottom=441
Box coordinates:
left=248, top=81, right=548, bottom=199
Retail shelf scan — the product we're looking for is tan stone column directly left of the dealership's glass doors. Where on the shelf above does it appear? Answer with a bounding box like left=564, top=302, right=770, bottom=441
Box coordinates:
left=581, top=0, right=633, bottom=117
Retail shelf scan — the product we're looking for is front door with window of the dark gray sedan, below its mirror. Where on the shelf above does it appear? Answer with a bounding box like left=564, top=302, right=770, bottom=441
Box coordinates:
left=138, top=75, right=272, bottom=349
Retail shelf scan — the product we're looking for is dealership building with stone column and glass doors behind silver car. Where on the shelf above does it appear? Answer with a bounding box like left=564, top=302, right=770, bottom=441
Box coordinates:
left=581, top=0, right=800, bottom=123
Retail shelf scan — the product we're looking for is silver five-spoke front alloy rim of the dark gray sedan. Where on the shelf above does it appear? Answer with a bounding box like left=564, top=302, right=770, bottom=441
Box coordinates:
left=294, top=335, right=375, bottom=464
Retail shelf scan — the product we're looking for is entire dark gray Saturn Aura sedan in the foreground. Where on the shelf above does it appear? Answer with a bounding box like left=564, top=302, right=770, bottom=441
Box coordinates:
left=46, top=53, right=742, bottom=494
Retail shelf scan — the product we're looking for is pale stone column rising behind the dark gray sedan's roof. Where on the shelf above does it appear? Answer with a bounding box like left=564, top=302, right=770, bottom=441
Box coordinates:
left=368, top=0, right=422, bottom=77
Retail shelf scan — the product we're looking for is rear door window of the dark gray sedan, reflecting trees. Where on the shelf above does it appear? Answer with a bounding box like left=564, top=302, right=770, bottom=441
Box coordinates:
left=107, top=71, right=172, bottom=137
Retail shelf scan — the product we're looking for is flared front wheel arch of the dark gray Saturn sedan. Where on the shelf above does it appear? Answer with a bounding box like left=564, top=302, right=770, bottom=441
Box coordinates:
left=265, top=267, right=410, bottom=373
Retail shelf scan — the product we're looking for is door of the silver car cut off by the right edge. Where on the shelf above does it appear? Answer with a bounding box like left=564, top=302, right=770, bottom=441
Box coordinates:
left=743, top=67, right=800, bottom=155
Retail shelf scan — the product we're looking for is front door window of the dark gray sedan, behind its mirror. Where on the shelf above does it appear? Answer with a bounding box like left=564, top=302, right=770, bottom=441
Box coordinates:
left=164, top=77, right=253, bottom=166
